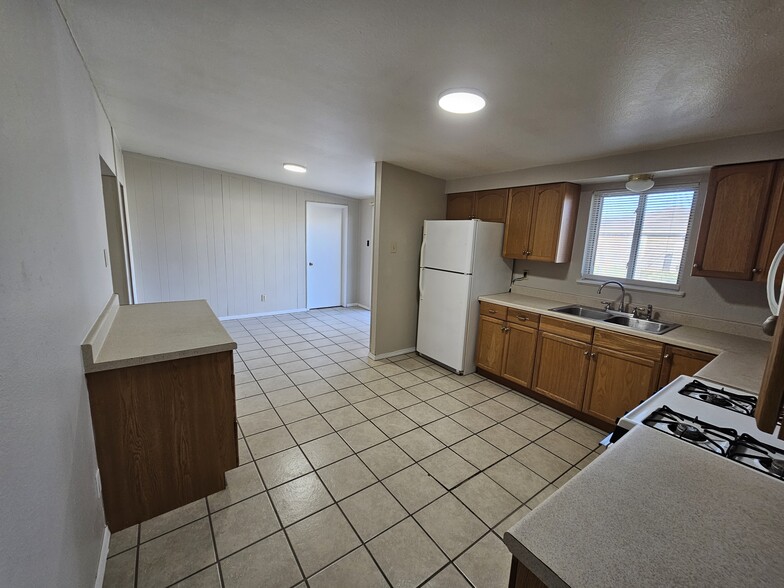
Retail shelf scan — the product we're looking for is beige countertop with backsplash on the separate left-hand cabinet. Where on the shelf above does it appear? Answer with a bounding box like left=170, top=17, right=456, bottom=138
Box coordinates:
left=82, top=295, right=237, bottom=373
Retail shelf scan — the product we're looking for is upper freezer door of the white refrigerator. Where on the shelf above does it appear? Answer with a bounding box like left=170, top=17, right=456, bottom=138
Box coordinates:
left=419, top=220, right=478, bottom=274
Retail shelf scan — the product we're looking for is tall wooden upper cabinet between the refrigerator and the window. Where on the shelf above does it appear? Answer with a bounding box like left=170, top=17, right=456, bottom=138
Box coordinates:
left=504, top=182, right=580, bottom=263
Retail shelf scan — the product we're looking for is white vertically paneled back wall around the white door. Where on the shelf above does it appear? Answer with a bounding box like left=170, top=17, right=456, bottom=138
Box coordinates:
left=125, top=153, right=360, bottom=316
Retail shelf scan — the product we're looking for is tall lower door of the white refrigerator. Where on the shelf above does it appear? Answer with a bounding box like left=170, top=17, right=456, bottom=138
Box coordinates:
left=417, top=269, right=472, bottom=372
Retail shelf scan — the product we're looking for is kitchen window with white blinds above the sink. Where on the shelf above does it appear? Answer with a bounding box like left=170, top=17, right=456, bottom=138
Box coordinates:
left=583, top=186, right=697, bottom=289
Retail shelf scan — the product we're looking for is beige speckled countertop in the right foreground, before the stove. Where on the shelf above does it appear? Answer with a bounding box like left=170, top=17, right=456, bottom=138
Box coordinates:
left=504, top=427, right=784, bottom=588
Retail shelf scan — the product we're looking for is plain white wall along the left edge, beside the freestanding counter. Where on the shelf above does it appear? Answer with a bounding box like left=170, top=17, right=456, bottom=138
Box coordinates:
left=0, top=0, right=121, bottom=587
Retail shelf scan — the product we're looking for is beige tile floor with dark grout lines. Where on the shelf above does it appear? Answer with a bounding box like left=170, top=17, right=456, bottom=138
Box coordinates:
left=104, top=308, right=604, bottom=588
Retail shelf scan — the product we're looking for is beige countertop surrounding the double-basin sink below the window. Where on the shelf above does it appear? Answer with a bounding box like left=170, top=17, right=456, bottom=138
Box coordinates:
left=479, top=292, right=770, bottom=394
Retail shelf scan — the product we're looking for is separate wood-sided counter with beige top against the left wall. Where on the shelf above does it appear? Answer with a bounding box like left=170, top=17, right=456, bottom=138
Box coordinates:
left=82, top=298, right=238, bottom=532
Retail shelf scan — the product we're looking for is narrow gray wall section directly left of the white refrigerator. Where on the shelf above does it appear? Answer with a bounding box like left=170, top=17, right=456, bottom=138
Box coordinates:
left=370, top=162, right=446, bottom=357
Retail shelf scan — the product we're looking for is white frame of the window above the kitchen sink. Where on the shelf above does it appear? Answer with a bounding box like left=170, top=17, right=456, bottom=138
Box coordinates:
left=580, top=183, right=700, bottom=293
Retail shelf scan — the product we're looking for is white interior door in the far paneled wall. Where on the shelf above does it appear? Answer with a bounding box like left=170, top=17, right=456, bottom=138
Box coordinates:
left=305, top=202, right=347, bottom=308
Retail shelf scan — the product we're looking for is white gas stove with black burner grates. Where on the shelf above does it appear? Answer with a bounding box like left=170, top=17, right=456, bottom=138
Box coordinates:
left=612, top=376, right=784, bottom=480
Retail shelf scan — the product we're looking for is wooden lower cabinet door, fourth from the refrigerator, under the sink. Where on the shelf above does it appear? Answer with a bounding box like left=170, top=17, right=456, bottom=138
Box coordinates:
left=583, top=347, right=660, bottom=424
